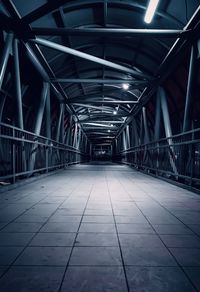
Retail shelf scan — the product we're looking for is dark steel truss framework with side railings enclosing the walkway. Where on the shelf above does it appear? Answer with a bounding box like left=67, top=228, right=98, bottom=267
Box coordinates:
left=0, top=0, right=200, bottom=187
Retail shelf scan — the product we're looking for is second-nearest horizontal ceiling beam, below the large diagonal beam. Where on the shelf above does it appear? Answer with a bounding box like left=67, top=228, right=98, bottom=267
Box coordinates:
left=51, top=78, right=148, bottom=84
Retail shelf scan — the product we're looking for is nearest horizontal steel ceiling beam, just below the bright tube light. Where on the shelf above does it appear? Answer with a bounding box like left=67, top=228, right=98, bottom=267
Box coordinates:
left=32, top=27, right=191, bottom=38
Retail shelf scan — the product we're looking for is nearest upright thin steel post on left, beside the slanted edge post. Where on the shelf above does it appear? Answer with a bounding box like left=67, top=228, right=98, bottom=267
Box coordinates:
left=13, top=39, right=24, bottom=130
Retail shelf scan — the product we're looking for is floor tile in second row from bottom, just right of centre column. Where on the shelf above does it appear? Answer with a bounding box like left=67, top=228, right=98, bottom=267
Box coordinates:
left=122, top=246, right=177, bottom=267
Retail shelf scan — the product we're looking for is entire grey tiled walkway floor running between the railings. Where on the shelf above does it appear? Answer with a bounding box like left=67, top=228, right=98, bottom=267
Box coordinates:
left=0, top=164, right=200, bottom=292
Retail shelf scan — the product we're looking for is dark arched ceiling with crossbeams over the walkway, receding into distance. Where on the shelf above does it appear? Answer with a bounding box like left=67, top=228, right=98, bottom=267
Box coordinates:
left=1, top=0, right=200, bottom=143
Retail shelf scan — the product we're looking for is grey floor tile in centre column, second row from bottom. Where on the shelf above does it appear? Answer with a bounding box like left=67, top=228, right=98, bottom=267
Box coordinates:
left=69, top=247, right=122, bottom=266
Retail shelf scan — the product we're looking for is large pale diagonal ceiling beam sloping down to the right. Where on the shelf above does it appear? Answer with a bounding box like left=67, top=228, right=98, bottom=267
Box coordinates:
left=31, top=38, right=149, bottom=79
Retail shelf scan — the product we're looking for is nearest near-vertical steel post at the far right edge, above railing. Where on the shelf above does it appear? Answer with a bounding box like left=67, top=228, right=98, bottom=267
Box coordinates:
left=183, top=44, right=198, bottom=132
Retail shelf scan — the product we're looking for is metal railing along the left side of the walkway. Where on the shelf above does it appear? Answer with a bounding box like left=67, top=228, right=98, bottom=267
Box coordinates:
left=0, top=123, right=88, bottom=183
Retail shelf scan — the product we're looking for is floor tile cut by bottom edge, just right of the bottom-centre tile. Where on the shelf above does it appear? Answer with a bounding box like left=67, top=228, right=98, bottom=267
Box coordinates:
left=126, top=267, right=195, bottom=292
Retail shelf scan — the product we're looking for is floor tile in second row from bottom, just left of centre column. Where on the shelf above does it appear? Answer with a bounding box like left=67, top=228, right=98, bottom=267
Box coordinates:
left=15, top=247, right=71, bottom=266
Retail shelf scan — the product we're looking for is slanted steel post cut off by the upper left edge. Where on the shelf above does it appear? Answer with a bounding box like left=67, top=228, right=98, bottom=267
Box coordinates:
left=0, top=33, right=13, bottom=89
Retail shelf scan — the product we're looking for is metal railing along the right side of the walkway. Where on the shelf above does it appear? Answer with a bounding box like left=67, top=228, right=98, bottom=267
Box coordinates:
left=115, top=129, right=200, bottom=189
